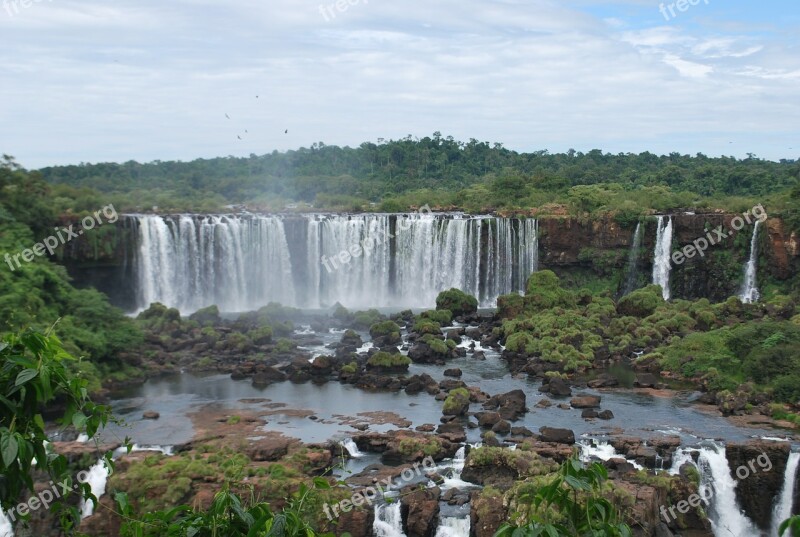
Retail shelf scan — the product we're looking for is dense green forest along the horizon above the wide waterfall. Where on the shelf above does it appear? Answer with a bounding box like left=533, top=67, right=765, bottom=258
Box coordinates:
left=34, top=132, right=800, bottom=218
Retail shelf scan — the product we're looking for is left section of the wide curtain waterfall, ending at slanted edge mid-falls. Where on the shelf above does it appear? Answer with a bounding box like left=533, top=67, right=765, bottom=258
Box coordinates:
left=136, top=215, right=295, bottom=312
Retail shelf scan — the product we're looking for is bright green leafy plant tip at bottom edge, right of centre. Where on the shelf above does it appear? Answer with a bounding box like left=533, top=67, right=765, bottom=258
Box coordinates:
left=495, top=458, right=631, bottom=537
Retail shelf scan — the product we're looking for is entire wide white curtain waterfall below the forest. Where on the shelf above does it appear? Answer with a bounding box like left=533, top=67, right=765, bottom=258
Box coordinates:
left=131, top=213, right=539, bottom=314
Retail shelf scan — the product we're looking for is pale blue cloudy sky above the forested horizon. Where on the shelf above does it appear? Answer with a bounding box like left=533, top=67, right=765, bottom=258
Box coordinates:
left=0, top=0, right=800, bottom=169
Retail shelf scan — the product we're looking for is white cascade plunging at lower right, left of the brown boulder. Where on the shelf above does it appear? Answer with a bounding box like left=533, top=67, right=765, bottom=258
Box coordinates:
left=669, top=444, right=761, bottom=537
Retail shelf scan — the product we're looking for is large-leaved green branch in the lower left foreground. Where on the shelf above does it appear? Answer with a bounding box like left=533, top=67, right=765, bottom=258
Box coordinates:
left=0, top=330, right=111, bottom=532
